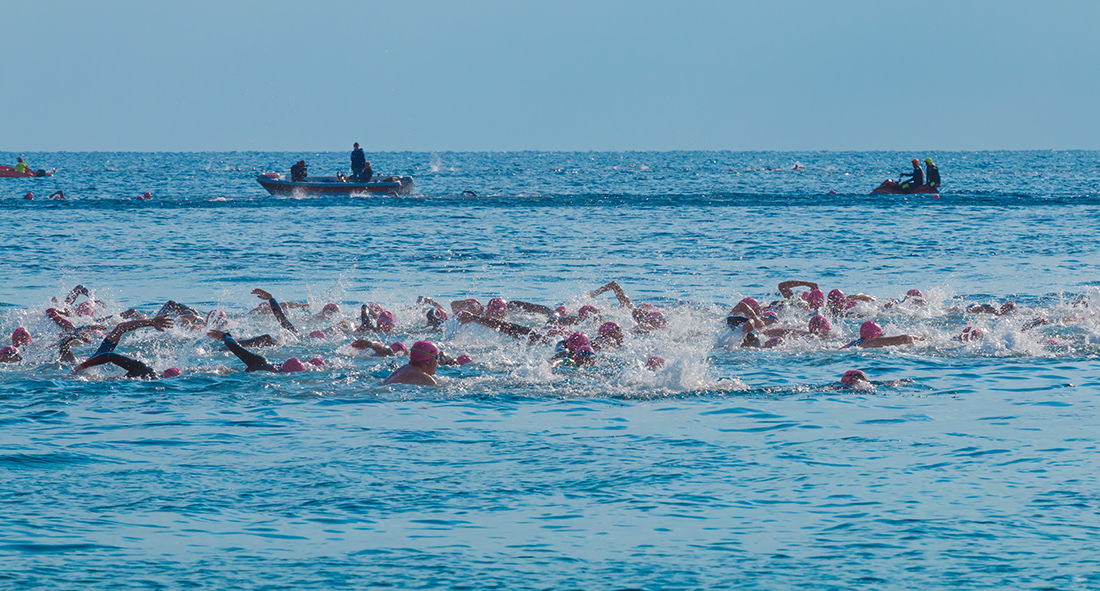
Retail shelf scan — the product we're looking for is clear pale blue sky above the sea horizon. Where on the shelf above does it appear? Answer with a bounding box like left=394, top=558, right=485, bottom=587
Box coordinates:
left=0, top=0, right=1100, bottom=152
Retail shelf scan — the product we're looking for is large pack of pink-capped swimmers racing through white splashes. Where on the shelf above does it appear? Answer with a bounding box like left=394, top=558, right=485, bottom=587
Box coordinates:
left=0, top=280, right=1087, bottom=387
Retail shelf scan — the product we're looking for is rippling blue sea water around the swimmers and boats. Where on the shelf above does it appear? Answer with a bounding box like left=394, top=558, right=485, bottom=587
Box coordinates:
left=0, top=152, right=1100, bottom=589
